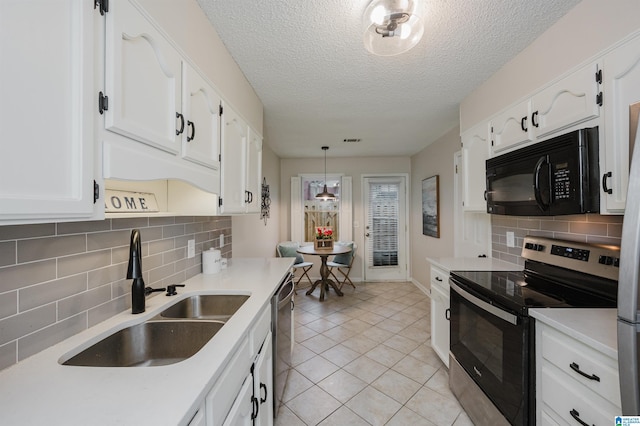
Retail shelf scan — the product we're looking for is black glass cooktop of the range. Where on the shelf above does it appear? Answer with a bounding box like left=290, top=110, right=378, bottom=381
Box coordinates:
left=451, top=271, right=616, bottom=314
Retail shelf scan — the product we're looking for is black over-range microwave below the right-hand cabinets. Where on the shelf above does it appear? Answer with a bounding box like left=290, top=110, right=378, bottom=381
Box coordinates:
left=485, top=127, right=600, bottom=216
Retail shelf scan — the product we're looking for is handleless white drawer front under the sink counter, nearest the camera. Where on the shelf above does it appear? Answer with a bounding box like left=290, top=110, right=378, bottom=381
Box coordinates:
left=205, top=337, right=253, bottom=426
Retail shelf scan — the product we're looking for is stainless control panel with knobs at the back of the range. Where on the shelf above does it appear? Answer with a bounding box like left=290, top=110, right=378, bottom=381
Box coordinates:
left=522, top=236, right=620, bottom=281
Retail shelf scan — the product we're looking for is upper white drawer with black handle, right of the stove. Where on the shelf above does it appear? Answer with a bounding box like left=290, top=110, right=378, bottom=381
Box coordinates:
left=542, top=327, right=620, bottom=406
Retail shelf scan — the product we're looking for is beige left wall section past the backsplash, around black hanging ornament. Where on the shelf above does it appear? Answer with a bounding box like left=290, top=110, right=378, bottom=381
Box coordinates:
left=231, top=144, right=284, bottom=257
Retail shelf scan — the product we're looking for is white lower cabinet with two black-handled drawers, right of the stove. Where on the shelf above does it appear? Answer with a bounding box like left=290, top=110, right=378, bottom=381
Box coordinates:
left=536, top=321, right=621, bottom=426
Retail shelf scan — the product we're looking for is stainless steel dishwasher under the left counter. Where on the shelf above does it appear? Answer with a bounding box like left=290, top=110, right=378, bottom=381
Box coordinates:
left=271, top=274, right=295, bottom=417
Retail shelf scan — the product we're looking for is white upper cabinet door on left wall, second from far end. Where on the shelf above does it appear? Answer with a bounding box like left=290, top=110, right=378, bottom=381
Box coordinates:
left=220, top=106, right=248, bottom=214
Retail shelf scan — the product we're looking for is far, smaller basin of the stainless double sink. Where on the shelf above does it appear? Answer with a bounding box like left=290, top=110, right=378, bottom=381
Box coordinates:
left=160, top=294, right=249, bottom=321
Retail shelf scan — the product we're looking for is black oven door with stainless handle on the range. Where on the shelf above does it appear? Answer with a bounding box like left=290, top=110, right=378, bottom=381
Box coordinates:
left=449, top=279, right=534, bottom=425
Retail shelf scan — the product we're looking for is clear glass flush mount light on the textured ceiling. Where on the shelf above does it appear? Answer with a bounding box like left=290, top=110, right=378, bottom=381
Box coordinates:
left=363, top=0, right=424, bottom=56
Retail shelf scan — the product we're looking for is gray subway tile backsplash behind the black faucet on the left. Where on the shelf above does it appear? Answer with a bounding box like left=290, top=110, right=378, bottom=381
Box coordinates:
left=0, top=216, right=232, bottom=369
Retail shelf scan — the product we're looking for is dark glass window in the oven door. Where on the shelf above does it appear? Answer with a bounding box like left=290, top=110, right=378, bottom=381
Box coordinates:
left=460, top=305, right=504, bottom=382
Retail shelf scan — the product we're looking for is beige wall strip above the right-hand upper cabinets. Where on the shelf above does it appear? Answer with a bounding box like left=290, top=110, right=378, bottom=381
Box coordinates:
left=460, top=0, right=640, bottom=132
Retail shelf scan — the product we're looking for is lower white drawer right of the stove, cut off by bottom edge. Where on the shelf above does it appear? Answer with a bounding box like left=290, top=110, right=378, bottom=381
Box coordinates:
left=538, top=362, right=620, bottom=425
